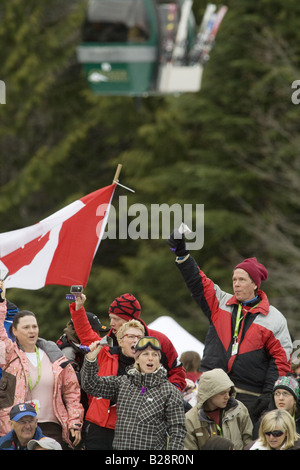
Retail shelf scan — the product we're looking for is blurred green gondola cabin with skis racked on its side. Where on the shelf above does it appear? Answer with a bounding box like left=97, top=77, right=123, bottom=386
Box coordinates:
left=77, top=0, right=227, bottom=96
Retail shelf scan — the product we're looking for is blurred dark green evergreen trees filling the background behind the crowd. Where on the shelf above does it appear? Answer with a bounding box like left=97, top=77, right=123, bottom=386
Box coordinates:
left=0, top=0, right=300, bottom=340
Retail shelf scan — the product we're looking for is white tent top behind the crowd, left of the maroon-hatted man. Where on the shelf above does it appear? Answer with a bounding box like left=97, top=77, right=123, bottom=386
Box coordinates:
left=148, top=315, right=204, bottom=358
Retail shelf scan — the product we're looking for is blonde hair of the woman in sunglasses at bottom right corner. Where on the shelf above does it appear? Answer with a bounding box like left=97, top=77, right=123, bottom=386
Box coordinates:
left=259, top=410, right=300, bottom=450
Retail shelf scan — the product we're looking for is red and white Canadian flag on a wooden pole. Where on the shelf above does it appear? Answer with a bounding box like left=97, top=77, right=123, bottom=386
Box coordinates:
left=0, top=184, right=116, bottom=289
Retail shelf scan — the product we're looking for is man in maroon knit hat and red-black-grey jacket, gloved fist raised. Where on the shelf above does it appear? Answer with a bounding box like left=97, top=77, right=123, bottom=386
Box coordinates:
left=168, top=230, right=292, bottom=422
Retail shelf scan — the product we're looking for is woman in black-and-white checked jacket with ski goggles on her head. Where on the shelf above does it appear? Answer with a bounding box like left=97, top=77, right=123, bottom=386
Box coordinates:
left=81, top=336, right=186, bottom=450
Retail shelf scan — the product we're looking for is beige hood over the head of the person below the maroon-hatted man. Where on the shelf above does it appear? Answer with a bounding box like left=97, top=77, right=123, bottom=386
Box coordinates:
left=197, top=369, right=236, bottom=409
